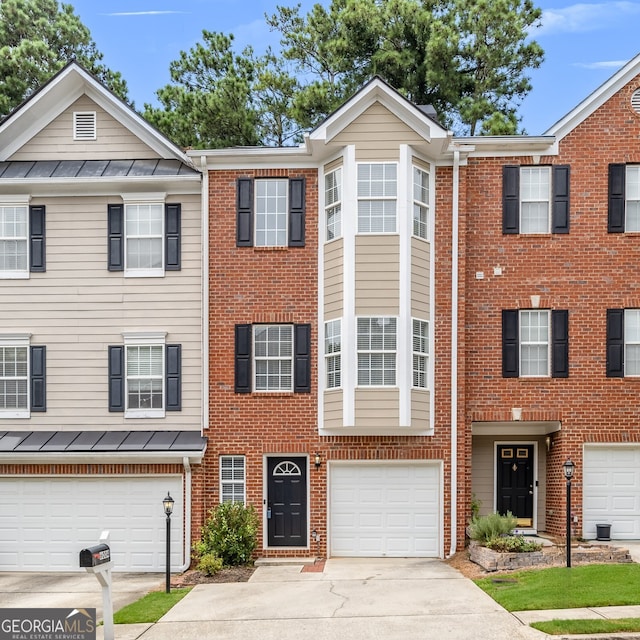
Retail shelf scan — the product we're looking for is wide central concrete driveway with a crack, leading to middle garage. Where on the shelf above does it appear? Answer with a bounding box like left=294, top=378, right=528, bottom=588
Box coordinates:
left=138, top=559, right=544, bottom=640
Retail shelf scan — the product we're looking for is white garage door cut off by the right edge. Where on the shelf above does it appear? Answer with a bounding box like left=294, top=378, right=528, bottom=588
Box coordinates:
left=582, top=445, right=640, bottom=540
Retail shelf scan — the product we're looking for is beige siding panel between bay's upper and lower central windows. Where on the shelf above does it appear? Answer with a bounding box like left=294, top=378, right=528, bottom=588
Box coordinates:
left=355, top=235, right=400, bottom=316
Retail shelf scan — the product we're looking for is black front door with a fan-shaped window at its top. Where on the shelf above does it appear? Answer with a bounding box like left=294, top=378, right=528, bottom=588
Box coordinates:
left=267, top=457, right=307, bottom=547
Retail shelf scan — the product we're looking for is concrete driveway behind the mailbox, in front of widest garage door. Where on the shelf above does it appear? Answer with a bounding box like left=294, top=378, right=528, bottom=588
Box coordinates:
left=0, top=571, right=164, bottom=620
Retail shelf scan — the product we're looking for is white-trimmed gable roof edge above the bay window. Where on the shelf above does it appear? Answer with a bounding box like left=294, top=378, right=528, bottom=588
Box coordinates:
left=307, top=76, right=452, bottom=158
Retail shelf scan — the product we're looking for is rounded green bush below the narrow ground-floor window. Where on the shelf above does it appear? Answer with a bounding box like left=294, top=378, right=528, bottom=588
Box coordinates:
left=194, top=502, right=259, bottom=566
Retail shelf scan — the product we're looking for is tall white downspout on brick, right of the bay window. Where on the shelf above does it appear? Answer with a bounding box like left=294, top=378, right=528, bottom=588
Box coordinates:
left=449, top=149, right=460, bottom=556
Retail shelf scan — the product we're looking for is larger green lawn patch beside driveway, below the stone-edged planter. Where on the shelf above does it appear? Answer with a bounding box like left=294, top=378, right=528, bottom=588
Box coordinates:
left=475, top=563, right=640, bottom=611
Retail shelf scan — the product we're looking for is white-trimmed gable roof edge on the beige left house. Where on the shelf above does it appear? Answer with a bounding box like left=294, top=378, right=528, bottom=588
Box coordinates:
left=0, top=62, right=192, bottom=165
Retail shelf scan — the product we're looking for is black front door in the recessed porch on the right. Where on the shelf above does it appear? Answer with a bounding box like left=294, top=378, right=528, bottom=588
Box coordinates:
left=497, top=444, right=533, bottom=527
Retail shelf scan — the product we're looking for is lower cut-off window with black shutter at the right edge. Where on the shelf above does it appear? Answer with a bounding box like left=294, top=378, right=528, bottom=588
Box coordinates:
left=607, top=309, right=640, bottom=378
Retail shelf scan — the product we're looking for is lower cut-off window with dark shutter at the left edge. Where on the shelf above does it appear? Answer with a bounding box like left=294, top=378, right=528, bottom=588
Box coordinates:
left=0, top=335, right=46, bottom=418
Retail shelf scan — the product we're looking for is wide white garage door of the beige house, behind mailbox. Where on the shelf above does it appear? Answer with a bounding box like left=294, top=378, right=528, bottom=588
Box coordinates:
left=0, top=476, right=183, bottom=571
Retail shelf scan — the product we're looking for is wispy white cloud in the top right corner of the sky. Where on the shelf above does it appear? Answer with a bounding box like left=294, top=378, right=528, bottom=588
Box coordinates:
left=533, top=0, right=640, bottom=37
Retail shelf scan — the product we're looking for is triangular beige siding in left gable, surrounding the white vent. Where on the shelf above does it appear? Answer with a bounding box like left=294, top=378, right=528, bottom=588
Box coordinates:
left=9, top=95, right=160, bottom=160
